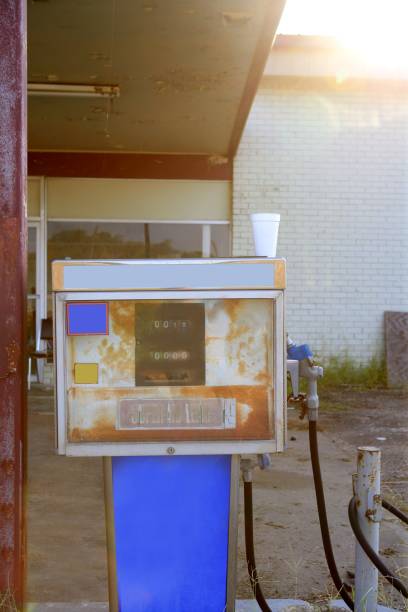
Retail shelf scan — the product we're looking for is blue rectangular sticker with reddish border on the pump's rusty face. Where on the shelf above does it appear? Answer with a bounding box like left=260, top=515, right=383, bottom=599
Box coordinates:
left=67, top=302, right=109, bottom=336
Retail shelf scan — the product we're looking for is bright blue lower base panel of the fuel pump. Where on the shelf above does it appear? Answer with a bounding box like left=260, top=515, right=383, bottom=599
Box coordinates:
left=108, top=455, right=232, bottom=612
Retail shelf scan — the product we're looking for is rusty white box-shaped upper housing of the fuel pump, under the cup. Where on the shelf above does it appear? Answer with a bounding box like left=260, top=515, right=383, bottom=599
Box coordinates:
left=52, top=258, right=286, bottom=456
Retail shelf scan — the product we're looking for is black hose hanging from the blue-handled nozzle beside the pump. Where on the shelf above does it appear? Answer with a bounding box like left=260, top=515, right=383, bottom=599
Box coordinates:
left=309, top=420, right=354, bottom=610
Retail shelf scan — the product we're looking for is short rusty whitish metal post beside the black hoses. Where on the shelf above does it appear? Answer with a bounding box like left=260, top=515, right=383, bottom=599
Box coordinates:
left=353, top=446, right=381, bottom=612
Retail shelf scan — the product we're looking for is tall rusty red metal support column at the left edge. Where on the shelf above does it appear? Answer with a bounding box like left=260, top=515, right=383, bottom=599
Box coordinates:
left=0, top=0, right=27, bottom=610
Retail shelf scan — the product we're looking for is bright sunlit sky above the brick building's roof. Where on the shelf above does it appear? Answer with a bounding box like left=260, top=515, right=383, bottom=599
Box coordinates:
left=279, top=0, right=408, bottom=66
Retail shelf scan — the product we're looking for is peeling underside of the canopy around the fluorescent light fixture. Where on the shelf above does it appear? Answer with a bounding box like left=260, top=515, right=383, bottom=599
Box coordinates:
left=28, top=0, right=284, bottom=156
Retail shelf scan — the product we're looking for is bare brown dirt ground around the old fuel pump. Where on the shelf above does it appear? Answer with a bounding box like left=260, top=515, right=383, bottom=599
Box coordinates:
left=28, top=386, right=408, bottom=609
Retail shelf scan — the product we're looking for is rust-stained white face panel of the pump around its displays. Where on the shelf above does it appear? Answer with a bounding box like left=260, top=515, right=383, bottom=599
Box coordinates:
left=66, top=298, right=274, bottom=442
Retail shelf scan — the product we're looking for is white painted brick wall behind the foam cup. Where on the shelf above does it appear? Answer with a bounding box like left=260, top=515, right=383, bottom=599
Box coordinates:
left=233, top=87, right=408, bottom=362
